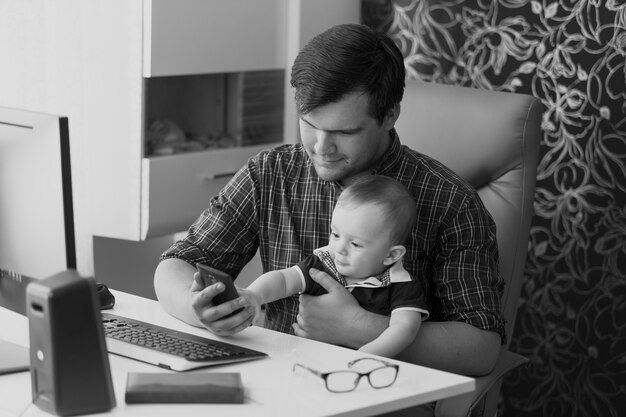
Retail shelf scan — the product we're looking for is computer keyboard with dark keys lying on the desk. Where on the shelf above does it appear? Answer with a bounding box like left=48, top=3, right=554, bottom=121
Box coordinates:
left=102, top=313, right=267, bottom=371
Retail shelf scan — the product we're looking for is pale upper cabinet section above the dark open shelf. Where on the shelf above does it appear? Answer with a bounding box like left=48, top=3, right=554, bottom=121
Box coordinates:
left=143, top=0, right=287, bottom=77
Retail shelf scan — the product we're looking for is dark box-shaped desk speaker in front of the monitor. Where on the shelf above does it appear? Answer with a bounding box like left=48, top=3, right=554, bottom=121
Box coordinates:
left=26, top=270, right=115, bottom=416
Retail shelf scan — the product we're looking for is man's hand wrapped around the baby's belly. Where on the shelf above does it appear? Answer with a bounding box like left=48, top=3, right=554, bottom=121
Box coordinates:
left=293, top=268, right=389, bottom=349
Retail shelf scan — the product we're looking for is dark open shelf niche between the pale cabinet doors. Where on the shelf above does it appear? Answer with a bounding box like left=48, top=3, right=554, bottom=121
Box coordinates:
left=144, top=70, right=285, bottom=157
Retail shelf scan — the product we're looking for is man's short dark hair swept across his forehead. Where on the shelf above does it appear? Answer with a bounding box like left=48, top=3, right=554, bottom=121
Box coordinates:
left=291, top=24, right=405, bottom=123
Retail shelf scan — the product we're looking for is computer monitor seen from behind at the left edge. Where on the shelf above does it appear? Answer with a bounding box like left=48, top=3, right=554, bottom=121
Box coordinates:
left=0, top=107, right=76, bottom=314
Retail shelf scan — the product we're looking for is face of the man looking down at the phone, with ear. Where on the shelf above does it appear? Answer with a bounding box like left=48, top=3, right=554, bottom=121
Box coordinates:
left=300, top=93, right=396, bottom=185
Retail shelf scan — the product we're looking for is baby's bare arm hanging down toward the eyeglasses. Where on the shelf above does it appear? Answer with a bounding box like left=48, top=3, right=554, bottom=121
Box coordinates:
left=359, top=309, right=422, bottom=358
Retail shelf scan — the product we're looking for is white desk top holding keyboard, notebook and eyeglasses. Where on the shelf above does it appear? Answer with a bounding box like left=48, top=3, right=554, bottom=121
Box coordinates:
left=0, top=291, right=474, bottom=417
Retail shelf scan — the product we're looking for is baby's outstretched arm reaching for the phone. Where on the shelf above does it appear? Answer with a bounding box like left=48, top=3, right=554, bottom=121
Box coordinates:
left=239, top=267, right=304, bottom=306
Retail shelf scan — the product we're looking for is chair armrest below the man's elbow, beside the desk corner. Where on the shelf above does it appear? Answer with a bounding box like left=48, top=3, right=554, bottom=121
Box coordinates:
left=435, top=349, right=528, bottom=417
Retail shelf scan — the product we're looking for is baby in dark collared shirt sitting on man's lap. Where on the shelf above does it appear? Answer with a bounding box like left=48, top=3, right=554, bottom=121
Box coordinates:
left=239, top=175, right=428, bottom=357
